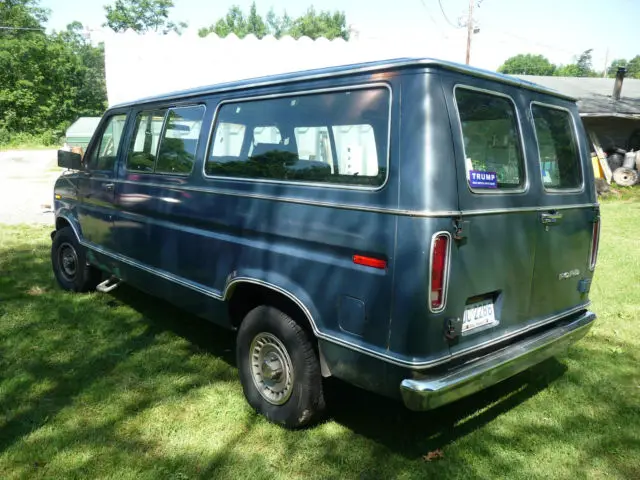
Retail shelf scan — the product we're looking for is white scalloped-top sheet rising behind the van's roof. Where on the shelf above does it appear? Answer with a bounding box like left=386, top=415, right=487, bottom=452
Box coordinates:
left=105, top=31, right=444, bottom=105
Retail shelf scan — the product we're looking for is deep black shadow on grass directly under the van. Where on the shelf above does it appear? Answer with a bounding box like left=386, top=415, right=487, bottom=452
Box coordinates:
left=113, top=286, right=566, bottom=459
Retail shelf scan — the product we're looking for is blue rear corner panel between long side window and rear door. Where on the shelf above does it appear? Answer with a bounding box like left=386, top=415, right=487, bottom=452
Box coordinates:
left=389, top=70, right=458, bottom=361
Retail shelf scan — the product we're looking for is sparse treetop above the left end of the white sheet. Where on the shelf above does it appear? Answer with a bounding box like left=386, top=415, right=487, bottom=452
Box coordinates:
left=102, top=0, right=187, bottom=35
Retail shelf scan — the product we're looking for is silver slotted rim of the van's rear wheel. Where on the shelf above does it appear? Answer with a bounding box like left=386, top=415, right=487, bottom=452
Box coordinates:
left=249, top=332, right=293, bottom=405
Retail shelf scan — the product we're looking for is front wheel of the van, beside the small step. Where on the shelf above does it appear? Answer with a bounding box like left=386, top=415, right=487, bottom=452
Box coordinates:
left=51, top=227, right=101, bottom=292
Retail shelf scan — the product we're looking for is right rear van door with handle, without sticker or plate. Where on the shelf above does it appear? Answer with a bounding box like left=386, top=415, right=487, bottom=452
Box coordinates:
left=530, top=102, right=599, bottom=319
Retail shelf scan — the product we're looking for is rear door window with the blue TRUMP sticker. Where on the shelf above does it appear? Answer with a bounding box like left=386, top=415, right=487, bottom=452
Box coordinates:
left=455, top=88, right=525, bottom=192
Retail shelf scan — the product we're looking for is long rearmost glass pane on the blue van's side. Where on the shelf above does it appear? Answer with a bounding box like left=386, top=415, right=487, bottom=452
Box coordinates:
left=205, top=87, right=391, bottom=187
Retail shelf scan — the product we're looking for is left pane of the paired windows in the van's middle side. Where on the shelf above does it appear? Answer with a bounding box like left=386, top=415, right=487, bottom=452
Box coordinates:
left=127, top=110, right=166, bottom=173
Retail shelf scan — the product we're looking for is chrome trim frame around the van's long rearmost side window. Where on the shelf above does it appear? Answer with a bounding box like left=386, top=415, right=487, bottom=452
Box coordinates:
left=202, top=82, right=393, bottom=192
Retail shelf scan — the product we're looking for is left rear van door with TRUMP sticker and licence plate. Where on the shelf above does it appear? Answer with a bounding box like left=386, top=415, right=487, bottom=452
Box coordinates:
left=445, top=81, right=539, bottom=355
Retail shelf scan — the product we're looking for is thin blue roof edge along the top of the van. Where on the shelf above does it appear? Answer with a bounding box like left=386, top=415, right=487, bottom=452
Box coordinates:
left=113, top=58, right=576, bottom=108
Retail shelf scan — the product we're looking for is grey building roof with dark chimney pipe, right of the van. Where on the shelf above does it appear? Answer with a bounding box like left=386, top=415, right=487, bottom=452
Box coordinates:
left=514, top=75, right=640, bottom=115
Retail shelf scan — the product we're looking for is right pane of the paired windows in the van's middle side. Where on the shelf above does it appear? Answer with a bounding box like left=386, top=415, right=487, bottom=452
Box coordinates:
left=155, top=106, right=204, bottom=175
